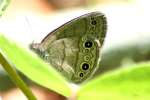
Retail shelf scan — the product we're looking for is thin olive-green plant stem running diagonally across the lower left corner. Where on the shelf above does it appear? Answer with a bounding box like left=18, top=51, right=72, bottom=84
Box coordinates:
left=0, top=51, right=37, bottom=100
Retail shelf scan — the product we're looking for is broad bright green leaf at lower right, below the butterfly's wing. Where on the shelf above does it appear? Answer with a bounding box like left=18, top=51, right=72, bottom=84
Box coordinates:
left=77, top=62, right=150, bottom=100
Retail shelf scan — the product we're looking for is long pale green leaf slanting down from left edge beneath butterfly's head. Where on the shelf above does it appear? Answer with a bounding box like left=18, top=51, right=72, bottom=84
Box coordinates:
left=0, top=35, right=71, bottom=97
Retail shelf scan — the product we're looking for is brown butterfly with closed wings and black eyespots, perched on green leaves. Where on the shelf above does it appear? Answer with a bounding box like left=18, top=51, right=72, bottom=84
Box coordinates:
left=31, top=12, right=107, bottom=83
